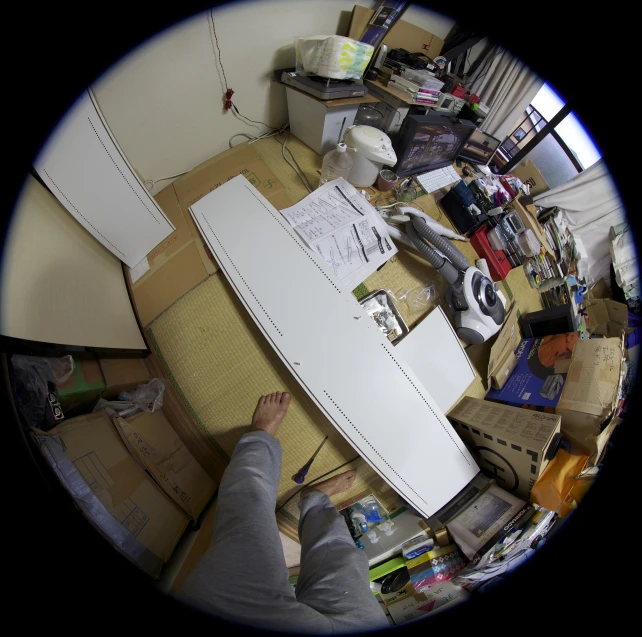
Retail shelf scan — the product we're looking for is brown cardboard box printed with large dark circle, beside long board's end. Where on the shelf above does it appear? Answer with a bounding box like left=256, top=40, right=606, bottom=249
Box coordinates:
left=448, top=396, right=562, bottom=501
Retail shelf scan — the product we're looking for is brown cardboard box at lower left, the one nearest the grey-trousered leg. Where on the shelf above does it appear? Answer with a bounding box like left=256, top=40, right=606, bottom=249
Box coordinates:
left=114, top=410, right=216, bottom=520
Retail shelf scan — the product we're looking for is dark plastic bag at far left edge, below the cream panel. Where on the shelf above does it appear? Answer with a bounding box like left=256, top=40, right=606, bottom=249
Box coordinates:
left=11, top=354, right=74, bottom=427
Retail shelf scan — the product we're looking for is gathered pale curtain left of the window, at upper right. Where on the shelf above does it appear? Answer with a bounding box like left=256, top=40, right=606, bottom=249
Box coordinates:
left=466, top=46, right=544, bottom=141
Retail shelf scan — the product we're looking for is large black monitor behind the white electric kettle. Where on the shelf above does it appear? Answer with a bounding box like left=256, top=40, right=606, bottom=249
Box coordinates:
left=393, top=113, right=475, bottom=177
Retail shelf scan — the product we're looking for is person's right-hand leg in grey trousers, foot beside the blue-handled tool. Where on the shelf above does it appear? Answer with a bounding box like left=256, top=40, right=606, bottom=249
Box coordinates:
left=296, top=471, right=389, bottom=633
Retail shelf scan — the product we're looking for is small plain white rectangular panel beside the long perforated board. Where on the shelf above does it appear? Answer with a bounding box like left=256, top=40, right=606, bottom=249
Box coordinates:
left=396, top=307, right=476, bottom=413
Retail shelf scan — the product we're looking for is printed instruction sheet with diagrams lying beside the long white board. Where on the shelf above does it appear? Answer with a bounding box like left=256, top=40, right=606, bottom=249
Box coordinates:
left=281, top=178, right=397, bottom=290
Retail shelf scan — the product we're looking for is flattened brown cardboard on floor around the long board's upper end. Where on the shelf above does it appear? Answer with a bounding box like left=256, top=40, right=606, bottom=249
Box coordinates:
left=129, top=144, right=293, bottom=327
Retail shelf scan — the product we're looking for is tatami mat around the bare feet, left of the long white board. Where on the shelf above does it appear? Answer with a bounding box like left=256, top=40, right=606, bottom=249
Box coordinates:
left=148, top=273, right=384, bottom=522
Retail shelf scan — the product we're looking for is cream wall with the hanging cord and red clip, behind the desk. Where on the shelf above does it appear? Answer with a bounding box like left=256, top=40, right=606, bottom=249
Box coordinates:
left=93, top=0, right=453, bottom=192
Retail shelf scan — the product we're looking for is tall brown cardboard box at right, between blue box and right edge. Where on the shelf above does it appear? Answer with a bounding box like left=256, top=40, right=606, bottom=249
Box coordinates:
left=555, top=338, right=624, bottom=455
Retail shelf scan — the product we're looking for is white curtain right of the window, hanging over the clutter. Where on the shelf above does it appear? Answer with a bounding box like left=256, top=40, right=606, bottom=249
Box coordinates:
left=534, top=159, right=626, bottom=287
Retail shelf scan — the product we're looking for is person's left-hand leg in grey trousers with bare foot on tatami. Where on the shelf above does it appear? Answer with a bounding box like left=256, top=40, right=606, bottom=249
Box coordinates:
left=176, top=392, right=329, bottom=633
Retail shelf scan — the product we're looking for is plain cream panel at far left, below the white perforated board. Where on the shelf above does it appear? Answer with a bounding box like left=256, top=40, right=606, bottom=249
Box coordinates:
left=0, top=176, right=146, bottom=349
